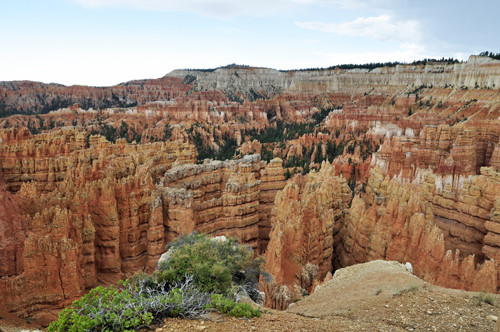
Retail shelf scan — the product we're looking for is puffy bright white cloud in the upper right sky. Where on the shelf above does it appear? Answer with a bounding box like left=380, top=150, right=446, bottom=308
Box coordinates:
left=295, top=15, right=420, bottom=43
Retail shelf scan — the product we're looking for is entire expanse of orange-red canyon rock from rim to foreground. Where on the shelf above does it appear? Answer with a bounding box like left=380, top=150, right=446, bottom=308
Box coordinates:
left=0, top=57, right=500, bottom=320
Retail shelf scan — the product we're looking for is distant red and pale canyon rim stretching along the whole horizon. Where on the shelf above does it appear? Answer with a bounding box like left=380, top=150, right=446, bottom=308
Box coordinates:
left=0, top=56, right=500, bottom=121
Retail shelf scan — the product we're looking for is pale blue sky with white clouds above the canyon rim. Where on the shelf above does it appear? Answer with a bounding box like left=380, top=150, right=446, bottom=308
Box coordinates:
left=0, top=0, right=500, bottom=86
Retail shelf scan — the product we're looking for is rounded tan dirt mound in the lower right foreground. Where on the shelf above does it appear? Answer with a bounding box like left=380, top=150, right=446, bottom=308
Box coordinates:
left=288, top=261, right=498, bottom=331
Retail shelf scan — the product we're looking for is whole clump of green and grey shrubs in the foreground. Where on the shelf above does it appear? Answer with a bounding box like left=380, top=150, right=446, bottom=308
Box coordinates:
left=48, top=232, right=265, bottom=332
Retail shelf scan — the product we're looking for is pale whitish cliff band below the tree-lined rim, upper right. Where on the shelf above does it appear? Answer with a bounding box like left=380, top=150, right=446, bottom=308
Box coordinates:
left=165, top=56, right=500, bottom=100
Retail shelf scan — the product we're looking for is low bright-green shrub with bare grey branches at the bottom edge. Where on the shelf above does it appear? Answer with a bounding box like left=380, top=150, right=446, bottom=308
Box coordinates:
left=48, top=277, right=210, bottom=332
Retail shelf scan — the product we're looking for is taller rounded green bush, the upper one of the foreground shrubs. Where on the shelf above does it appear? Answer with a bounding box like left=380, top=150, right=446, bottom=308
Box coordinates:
left=157, top=232, right=264, bottom=294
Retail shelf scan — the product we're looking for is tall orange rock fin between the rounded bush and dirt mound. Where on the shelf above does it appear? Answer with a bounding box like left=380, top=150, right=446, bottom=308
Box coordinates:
left=265, top=162, right=351, bottom=290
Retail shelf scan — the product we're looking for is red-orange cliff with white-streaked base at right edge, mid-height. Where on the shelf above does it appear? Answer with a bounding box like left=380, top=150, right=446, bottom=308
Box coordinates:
left=372, top=120, right=500, bottom=183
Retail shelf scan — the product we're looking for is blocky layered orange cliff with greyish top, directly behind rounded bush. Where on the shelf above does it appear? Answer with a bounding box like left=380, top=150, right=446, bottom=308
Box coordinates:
left=159, top=155, right=284, bottom=253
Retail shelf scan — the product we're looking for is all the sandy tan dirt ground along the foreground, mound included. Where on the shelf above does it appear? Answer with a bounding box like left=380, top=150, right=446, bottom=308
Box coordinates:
left=0, top=261, right=498, bottom=332
